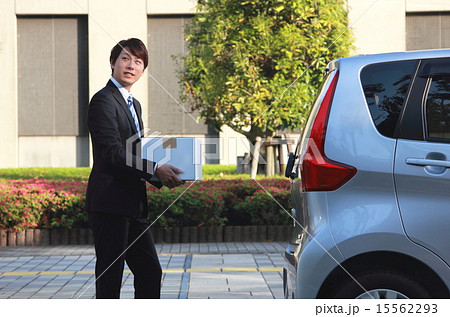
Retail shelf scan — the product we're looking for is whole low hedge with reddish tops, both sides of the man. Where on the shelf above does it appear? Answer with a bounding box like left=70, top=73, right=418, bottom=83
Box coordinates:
left=0, top=178, right=291, bottom=230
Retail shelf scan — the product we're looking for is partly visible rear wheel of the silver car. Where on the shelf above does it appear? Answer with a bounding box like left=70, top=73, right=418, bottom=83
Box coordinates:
left=330, top=271, right=431, bottom=299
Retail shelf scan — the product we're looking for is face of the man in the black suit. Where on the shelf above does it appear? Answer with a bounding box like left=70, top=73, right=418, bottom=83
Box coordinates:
left=111, top=47, right=144, bottom=90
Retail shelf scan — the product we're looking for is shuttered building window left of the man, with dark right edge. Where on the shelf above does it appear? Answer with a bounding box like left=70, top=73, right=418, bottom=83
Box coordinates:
left=17, top=16, right=89, bottom=136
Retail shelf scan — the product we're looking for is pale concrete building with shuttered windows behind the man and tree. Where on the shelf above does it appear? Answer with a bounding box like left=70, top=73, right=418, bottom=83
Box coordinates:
left=0, top=0, right=450, bottom=168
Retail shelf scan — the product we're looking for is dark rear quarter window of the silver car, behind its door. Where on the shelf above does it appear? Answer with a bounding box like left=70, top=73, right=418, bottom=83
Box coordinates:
left=361, top=61, right=417, bottom=137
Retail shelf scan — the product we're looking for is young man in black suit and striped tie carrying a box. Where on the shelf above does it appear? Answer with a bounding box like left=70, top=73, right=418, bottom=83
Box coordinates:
left=86, top=38, right=182, bottom=298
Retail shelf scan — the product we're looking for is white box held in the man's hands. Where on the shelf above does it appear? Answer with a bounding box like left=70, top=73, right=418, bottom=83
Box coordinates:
left=141, top=137, right=202, bottom=181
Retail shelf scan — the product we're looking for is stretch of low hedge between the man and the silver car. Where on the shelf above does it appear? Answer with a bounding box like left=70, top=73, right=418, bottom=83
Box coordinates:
left=149, top=178, right=291, bottom=227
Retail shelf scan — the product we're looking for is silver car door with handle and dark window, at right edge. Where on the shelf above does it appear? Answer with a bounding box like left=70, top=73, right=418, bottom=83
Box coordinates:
left=394, top=59, right=450, bottom=264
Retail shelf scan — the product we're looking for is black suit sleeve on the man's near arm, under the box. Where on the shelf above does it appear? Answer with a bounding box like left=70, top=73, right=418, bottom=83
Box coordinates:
left=88, top=90, right=155, bottom=181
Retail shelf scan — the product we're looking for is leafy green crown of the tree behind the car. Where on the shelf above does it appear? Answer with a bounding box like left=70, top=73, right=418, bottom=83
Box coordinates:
left=180, top=0, right=351, bottom=141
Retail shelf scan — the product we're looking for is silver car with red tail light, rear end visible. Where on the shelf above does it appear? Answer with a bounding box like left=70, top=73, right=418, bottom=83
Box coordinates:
left=284, top=50, right=450, bottom=298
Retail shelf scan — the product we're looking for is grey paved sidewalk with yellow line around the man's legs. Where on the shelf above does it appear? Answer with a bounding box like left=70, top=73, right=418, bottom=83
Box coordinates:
left=0, top=242, right=285, bottom=299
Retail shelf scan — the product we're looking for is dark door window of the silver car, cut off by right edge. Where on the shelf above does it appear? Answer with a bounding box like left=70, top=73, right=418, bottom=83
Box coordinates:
left=425, top=75, right=450, bottom=139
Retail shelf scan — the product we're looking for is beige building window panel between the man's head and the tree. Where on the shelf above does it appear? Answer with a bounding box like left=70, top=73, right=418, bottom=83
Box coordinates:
left=148, top=16, right=214, bottom=135
